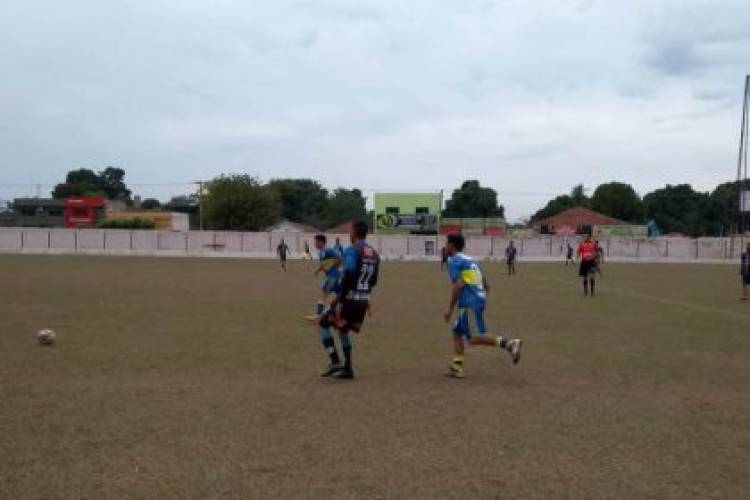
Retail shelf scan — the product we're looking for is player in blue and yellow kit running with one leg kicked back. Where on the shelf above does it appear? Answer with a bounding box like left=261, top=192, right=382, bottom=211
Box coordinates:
left=443, top=234, right=523, bottom=378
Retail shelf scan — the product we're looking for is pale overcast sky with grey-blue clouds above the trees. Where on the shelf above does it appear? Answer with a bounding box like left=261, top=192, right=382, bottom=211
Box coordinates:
left=0, top=0, right=750, bottom=219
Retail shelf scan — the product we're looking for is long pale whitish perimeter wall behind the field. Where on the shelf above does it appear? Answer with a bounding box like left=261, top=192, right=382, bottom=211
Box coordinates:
left=0, top=228, right=747, bottom=262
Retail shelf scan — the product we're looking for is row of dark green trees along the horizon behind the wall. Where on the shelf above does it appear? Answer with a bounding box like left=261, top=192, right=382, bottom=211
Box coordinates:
left=52, top=167, right=750, bottom=236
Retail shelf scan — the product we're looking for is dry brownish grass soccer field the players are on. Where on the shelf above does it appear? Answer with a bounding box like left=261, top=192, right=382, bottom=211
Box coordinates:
left=0, top=256, right=750, bottom=500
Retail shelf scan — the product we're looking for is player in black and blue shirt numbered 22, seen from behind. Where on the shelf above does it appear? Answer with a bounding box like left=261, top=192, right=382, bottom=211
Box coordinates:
left=319, top=222, right=380, bottom=379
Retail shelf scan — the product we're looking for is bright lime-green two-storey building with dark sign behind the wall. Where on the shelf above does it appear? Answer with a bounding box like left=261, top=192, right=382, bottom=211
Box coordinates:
left=373, top=192, right=443, bottom=234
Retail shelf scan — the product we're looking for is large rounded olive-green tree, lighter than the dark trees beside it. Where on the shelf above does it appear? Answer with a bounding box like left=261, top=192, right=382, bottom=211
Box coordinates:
left=202, top=174, right=281, bottom=231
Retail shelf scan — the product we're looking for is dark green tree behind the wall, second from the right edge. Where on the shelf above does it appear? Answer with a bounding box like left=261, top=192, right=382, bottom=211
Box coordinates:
left=643, top=184, right=710, bottom=237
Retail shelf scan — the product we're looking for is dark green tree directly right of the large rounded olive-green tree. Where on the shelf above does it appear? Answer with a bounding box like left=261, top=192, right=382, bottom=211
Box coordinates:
left=268, top=179, right=328, bottom=226
